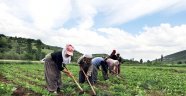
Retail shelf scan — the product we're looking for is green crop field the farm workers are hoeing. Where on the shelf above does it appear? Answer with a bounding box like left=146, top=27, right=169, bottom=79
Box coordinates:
left=0, top=63, right=186, bottom=96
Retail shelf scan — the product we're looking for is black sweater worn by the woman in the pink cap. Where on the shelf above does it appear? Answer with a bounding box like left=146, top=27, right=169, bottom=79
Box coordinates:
left=51, top=51, right=65, bottom=71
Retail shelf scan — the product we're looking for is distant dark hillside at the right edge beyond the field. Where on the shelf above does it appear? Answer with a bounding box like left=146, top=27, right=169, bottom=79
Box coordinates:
left=163, top=50, right=186, bottom=62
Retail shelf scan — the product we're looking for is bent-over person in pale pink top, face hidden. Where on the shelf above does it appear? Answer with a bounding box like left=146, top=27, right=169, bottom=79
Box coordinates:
left=106, top=58, right=119, bottom=74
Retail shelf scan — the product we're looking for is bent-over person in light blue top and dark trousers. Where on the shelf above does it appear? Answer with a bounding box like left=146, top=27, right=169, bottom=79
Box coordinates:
left=91, top=57, right=108, bottom=83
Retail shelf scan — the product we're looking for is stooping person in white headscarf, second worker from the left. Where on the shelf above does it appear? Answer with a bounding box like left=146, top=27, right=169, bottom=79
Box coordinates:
left=77, top=54, right=93, bottom=84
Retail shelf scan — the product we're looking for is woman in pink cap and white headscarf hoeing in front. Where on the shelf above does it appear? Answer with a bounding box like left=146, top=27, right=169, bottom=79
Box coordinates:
left=44, top=44, right=74, bottom=93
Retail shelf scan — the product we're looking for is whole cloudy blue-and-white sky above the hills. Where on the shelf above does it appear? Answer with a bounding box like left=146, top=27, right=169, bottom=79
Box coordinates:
left=0, top=0, right=186, bottom=61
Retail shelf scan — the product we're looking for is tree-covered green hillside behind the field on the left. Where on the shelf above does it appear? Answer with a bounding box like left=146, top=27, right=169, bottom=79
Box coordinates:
left=0, top=34, right=81, bottom=61
